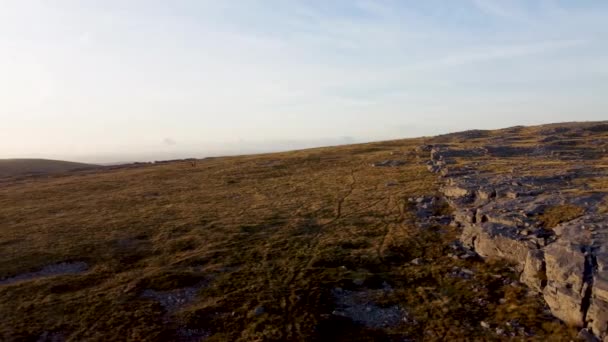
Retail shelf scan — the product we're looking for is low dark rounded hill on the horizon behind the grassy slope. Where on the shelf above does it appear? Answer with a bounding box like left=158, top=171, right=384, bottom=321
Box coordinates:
left=0, top=159, right=98, bottom=177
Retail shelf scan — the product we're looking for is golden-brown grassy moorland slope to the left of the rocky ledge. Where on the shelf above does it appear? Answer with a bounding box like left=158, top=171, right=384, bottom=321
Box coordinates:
left=0, top=127, right=600, bottom=341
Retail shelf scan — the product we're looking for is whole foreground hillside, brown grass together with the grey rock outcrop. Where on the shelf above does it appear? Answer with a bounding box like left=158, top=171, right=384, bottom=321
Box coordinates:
left=0, top=123, right=608, bottom=341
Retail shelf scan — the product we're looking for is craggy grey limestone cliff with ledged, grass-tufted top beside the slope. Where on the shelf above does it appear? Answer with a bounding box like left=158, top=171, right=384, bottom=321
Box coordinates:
left=420, top=123, right=608, bottom=341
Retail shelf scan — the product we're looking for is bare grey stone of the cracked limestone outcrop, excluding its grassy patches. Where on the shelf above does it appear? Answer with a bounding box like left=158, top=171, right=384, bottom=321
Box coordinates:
left=427, top=139, right=608, bottom=341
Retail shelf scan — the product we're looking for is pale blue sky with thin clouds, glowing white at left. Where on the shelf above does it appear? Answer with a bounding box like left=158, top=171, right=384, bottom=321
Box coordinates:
left=0, top=0, right=608, bottom=162
